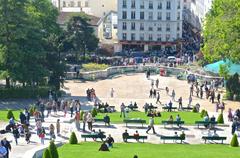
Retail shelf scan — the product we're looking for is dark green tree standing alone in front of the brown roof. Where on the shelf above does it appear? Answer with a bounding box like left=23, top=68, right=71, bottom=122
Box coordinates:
left=67, top=14, right=99, bottom=59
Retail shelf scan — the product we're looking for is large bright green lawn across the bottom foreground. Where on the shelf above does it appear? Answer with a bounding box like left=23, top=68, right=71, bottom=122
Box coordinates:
left=58, top=143, right=240, bottom=158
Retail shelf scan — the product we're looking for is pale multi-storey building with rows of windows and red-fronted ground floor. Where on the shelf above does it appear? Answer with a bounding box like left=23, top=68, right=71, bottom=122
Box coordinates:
left=116, top=0, right=183, bottom=51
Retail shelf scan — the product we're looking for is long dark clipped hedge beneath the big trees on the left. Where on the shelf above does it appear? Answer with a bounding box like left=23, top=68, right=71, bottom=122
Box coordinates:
left=0, top=87, right=51, bottom=99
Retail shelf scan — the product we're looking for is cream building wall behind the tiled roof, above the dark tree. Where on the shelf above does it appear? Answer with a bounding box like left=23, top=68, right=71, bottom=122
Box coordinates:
left=52, top=0, right=117, bottom=17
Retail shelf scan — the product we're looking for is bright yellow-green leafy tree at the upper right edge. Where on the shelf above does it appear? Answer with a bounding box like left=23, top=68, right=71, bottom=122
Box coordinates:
left=202, top=0, right=240, bottom=62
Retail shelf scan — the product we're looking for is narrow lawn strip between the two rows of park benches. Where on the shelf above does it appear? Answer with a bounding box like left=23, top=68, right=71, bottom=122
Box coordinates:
left=96, top=112, right=202, bottom=125
